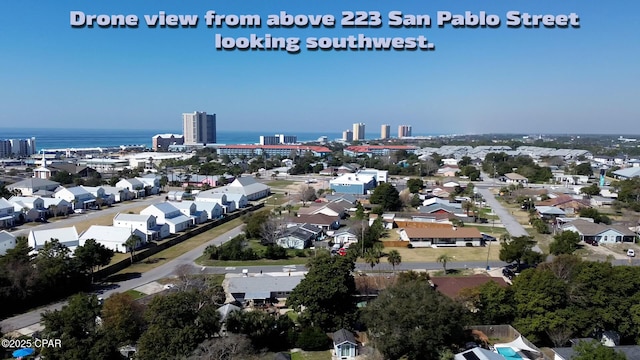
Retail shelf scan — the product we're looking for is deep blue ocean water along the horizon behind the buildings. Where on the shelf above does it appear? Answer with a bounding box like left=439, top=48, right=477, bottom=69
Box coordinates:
left=0, top=128, right=342, bottom=151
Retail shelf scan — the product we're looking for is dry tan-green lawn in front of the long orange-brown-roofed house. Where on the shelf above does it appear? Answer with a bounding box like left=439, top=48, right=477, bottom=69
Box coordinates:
left=380, top=241, right=500, bottom=264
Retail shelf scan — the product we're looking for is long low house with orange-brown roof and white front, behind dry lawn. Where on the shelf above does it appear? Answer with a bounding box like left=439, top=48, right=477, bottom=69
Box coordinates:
left=400, top=227, right=484, bottom=247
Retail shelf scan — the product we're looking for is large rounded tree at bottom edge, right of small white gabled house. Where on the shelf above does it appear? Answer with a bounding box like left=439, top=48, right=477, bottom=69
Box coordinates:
left=362, top=280, right=466, bottom=360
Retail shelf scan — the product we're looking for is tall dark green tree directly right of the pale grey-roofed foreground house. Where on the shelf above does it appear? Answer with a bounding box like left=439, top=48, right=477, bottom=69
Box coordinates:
left=287, top=254, right=356, bottom=331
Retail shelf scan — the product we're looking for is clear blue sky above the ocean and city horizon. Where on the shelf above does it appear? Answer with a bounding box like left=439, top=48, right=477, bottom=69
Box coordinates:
left=0, top=0, right=640, bottom=136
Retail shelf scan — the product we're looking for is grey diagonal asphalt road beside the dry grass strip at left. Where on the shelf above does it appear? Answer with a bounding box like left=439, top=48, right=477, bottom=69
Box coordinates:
left=0, top=226, right=245, bottom=332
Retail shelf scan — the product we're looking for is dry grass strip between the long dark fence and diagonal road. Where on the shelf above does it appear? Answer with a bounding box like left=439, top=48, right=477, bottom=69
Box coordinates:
left=118, top=219, right=242, bottom=274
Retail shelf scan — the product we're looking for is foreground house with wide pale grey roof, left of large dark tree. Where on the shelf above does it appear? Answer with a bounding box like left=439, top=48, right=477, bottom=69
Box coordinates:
left=225, top=273, right=304, bottom=303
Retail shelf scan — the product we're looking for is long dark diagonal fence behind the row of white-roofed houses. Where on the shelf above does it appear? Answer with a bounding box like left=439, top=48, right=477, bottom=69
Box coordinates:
left=93, top=203, right=264, bottom=279
